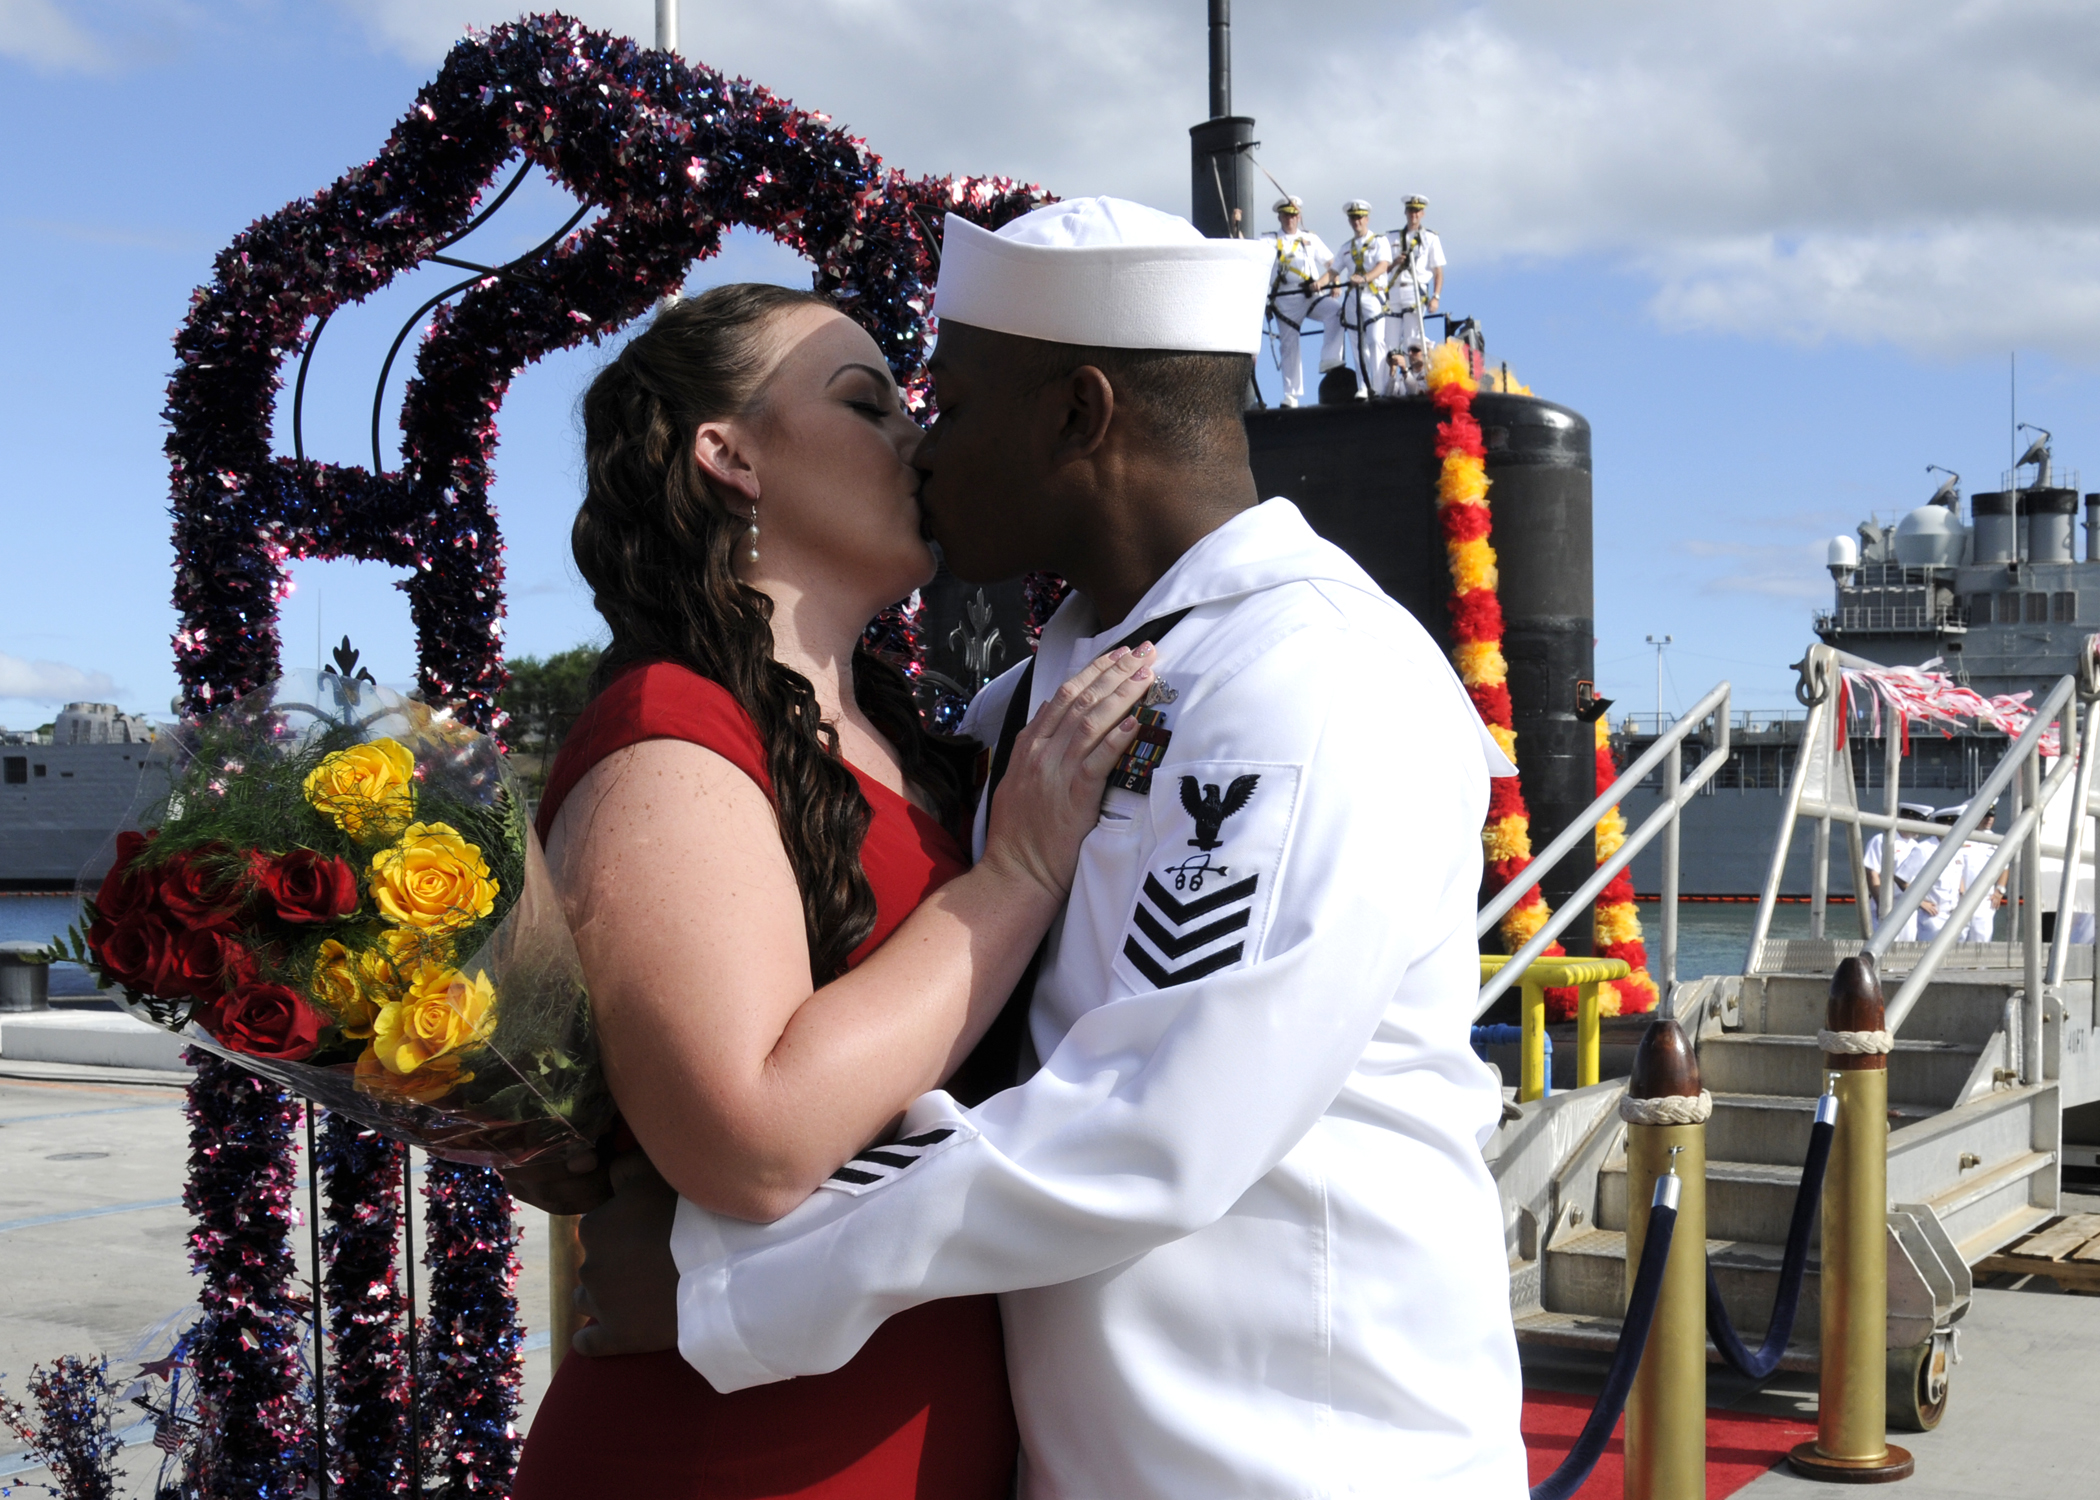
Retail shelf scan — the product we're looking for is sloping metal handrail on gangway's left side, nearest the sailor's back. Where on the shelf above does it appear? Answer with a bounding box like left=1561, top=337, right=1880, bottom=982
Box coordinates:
left=1472, top=683, right=1730, bottom=1019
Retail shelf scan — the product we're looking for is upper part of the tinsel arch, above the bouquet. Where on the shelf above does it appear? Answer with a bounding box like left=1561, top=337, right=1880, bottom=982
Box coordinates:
left=166, top=17, right=1044, bottom=729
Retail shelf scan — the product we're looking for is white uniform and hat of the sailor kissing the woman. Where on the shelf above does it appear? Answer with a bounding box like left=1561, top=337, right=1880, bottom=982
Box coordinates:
left=672, top=200, right=1525, bottom=1500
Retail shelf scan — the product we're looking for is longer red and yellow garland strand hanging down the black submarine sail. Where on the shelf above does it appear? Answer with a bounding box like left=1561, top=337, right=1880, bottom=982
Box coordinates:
left=1428, top=342, right=1562, bottom=954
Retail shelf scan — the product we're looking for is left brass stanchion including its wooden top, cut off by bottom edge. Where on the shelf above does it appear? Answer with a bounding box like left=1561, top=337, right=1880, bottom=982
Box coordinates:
left=1619, top=1017, right=1714, bottom=1500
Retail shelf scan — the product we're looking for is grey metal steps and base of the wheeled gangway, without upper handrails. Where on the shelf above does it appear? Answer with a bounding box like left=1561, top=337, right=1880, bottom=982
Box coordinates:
left=1491, top=957, right=2066, bottom=1422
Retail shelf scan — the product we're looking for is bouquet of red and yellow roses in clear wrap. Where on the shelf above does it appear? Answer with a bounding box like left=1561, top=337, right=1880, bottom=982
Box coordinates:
left=55, top=658, right=611, bottom=1166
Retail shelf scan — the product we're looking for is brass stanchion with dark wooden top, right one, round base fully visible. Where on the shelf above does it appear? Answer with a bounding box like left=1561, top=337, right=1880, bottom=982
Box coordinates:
left=1787, top=954, right=1913, bottom=1483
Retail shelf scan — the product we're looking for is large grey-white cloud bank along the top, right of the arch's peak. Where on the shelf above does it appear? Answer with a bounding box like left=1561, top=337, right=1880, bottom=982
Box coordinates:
left=323, top=0, right=2100, bottom=357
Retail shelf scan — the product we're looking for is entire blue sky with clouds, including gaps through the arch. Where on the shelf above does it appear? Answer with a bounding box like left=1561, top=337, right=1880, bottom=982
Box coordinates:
left=0, top=0, right=2100, bottom=725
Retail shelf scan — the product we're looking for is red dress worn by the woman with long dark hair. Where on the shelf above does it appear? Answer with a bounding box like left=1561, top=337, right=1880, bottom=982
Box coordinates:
left=512, top=662, right=1019, bottom=1500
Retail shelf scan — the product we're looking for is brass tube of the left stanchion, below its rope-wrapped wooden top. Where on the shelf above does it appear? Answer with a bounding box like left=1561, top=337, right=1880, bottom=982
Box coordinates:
left=1625, top=1124, right=1707, bottom=1500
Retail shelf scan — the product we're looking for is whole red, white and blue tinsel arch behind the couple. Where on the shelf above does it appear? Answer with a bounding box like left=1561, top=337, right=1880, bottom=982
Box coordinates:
left=166, top=15, right=1048, bottom=1498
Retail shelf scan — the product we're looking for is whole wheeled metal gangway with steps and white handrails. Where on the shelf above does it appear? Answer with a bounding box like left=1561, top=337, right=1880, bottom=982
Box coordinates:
left=1481, top=637, right=2100, bottom=1426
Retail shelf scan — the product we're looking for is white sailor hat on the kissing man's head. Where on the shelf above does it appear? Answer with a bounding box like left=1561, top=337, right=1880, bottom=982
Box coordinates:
left=932, top=197, right=1275, bottom=355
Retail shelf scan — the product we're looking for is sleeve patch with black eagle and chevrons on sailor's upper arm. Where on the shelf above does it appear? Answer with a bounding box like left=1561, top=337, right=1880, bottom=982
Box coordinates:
left=1115, top=761, right=1298, bottom=989
